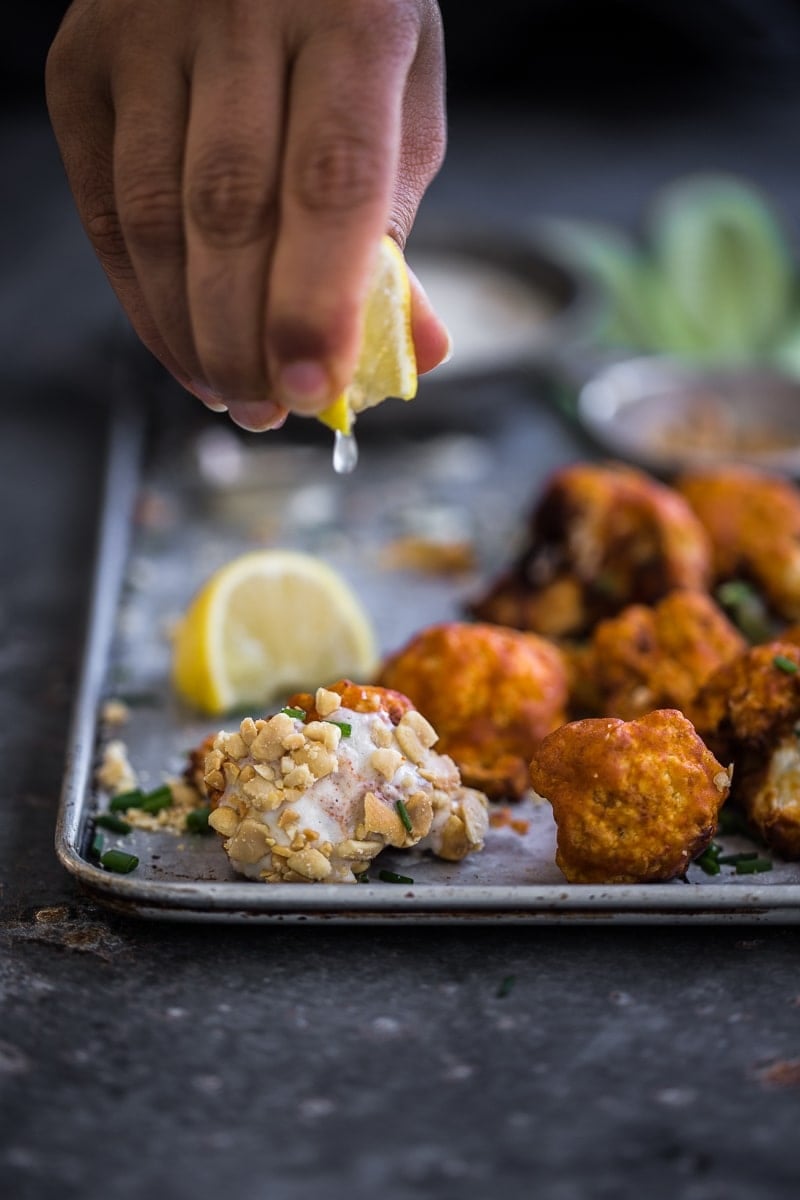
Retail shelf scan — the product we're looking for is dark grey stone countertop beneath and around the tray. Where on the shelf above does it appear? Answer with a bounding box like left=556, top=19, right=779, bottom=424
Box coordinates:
left=0, top=103, right=800, bottom=1200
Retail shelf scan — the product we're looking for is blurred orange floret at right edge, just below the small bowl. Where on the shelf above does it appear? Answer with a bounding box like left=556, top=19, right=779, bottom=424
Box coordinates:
left=675, top=466, right=800, bottom=620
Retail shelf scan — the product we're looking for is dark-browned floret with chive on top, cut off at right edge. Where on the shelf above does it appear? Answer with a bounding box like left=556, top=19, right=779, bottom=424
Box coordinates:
left=691, top=641, right=800, bottom=859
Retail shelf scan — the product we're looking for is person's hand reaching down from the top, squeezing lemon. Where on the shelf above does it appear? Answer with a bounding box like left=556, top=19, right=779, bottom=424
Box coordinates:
left=47, top=0, right=449, bottom=430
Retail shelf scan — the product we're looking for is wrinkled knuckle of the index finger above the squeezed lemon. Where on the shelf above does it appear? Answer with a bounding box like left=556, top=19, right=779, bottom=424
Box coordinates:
left=293, top=128, right=384, bottom=212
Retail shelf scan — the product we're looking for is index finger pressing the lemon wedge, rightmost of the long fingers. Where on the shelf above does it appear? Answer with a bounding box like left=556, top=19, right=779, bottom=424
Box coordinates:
left=266, top=0, right=419, bottom=414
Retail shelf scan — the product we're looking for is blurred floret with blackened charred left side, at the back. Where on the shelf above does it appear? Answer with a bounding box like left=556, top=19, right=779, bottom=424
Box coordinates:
left=471, top=463, right=710, bottom=638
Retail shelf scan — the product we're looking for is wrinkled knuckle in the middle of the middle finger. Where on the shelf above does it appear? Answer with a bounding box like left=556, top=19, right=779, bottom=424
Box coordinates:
left=187, top=146, right=275, bottom=248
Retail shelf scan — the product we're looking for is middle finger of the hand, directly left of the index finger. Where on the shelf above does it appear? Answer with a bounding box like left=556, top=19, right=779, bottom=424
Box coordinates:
left=184, top=5, right=287, bottom=428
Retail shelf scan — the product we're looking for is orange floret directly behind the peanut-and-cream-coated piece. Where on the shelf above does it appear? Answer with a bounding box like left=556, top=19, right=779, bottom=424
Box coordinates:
left=379, top=622, right=567, bottom=799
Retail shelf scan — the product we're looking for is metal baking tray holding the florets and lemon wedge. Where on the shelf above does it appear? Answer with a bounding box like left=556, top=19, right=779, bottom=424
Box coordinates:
left=56, top=345, right=800, bottom=924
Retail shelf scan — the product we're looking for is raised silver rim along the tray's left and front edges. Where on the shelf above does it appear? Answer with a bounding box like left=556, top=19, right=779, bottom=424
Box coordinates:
left=55, top=355, right=800, bottom=924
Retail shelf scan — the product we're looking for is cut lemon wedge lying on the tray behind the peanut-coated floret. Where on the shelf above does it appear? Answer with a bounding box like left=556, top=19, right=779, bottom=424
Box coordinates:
left=173, top=550, right=377, bottom=714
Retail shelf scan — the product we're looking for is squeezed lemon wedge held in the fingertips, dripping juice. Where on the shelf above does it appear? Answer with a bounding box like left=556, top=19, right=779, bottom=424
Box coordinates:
left=318, top=236, right=417, bottom=434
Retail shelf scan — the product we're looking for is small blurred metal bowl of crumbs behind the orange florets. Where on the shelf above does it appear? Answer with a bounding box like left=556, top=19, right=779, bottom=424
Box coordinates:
left=577, top=358, right=800, bottom=475
